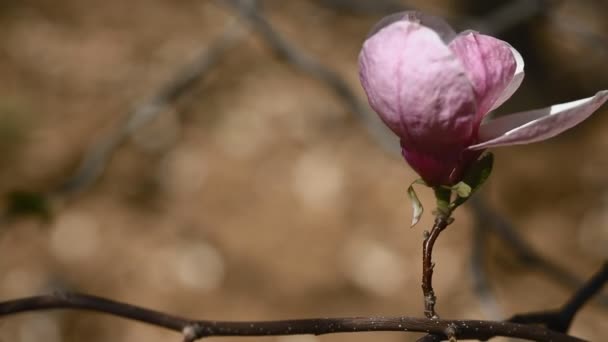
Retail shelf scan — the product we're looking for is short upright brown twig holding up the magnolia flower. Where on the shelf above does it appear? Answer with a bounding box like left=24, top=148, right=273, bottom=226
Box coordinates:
left=422, top=215, right=450, bottom=319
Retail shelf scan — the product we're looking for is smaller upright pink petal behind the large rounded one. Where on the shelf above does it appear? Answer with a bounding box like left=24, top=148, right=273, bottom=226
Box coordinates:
left=449, top=31, right=517, bottom=121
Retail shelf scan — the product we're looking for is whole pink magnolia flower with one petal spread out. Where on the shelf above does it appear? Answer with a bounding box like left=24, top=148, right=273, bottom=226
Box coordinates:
left=359, top=12, right=608, bottom=186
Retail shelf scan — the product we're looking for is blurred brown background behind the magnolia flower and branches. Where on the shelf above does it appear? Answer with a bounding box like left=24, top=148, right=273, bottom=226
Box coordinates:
left=0, top=0, right=608, bottom=342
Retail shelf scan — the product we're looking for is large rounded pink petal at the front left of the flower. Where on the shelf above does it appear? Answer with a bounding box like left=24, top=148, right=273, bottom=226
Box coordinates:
left=359, top=20, right=477, bottom=151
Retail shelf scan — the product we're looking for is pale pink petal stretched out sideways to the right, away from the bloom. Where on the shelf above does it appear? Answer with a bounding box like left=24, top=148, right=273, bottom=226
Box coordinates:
left=469, top=90, right=608, bottom=150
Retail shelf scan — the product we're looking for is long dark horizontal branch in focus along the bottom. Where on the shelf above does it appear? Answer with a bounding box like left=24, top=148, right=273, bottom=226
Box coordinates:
left=0, top=293, right=584, bottom=342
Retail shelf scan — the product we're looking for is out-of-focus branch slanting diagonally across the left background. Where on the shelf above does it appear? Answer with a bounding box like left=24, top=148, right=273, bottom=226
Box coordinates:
left=0, top=22, right=244, bottom=225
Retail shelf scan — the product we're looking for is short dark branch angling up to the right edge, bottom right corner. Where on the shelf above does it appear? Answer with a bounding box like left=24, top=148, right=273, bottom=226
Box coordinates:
left=509, top=261, right=608, bottom=333
